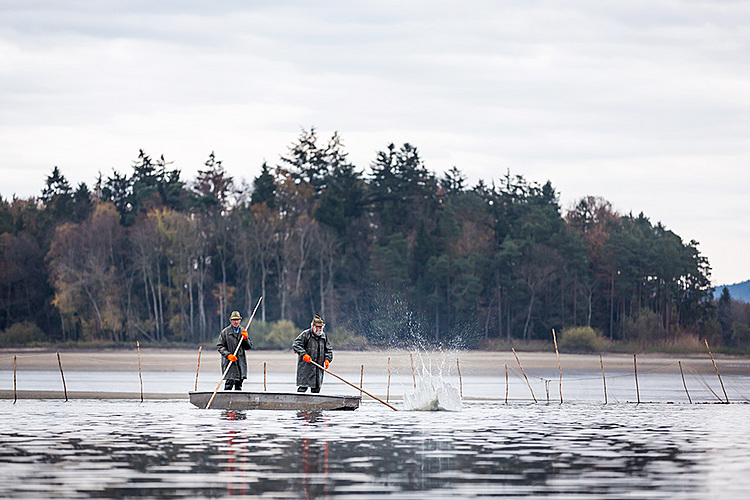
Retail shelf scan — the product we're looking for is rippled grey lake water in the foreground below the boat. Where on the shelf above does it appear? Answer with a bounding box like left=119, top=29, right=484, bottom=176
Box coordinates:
left=0, top=391, right=750, bottom=499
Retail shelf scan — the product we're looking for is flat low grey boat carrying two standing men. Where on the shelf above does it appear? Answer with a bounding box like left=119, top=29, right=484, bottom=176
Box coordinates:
left=188, top=391, right=362, bottom=410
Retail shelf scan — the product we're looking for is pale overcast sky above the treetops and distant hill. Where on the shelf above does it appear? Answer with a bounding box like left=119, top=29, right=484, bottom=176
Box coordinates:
left=0, top=0, right=750, bottom=285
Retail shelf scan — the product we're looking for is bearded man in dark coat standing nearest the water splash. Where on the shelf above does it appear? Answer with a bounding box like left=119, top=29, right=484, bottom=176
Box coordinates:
left=292, top=314, right=333, bottom=393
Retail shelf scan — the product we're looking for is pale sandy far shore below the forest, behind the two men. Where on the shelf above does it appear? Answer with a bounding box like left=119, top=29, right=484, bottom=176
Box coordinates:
left=0, top=346, right=750, bottom=376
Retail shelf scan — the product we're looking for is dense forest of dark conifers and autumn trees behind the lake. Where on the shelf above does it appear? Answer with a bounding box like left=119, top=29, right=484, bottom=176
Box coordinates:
left=0, top=129, right=750, bottom=347
